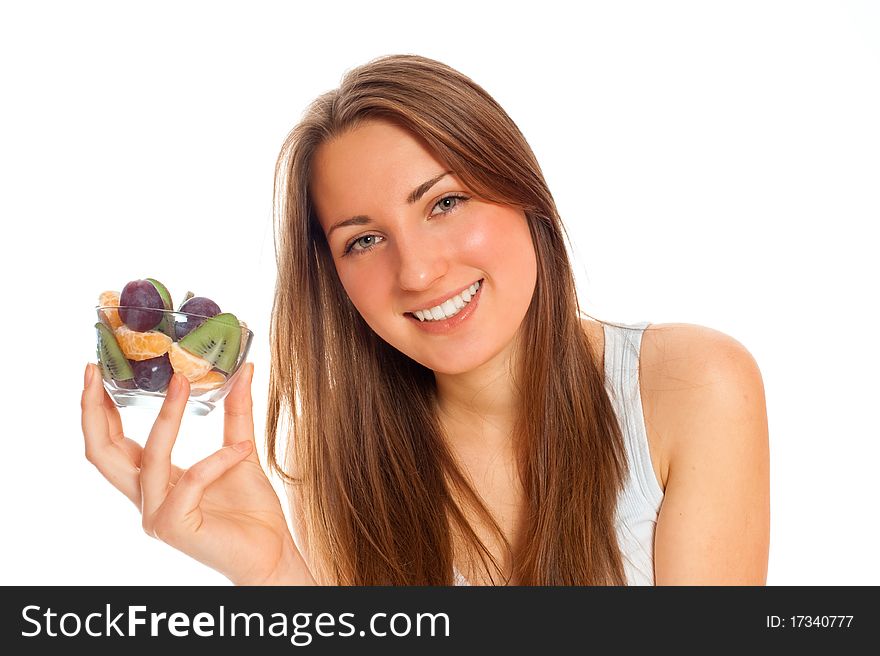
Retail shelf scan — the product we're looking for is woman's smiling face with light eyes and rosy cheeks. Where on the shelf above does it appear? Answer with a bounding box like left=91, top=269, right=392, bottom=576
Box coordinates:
left=310, top=120, right=537, bottom=374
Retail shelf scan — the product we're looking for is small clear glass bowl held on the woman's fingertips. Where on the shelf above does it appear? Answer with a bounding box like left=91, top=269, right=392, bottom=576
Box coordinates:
left=95, top=306, right=254, bottom=415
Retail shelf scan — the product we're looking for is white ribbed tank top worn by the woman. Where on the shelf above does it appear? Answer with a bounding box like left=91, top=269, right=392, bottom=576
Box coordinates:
left=453, top=321, right=663, bottom=585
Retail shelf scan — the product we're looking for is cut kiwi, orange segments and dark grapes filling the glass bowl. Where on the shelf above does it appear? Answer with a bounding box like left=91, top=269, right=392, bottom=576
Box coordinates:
left=95, top=278, right=250, bottom=395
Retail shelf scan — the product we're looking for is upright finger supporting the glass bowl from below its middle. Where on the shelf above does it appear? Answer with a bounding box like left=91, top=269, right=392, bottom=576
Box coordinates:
left=140, top=374, right=189, bottom=527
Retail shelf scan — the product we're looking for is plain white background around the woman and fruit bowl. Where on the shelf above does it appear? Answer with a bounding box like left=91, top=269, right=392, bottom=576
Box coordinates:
left=0, top=0, right=880, bottom=585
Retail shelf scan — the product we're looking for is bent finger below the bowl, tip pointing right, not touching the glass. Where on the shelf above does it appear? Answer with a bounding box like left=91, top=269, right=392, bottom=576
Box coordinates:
left=163, top=440, right=254, bottom=525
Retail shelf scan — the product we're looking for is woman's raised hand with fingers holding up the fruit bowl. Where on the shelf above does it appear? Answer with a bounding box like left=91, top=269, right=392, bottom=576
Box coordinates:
left=82, top=363, right=314, bottom=585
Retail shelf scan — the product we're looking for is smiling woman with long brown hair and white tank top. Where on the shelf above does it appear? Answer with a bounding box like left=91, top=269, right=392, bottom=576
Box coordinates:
left=83, top=56, right=769, bottom=585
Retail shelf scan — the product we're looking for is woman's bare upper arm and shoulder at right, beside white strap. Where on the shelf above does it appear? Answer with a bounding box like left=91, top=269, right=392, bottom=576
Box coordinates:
left=654, top=326, right=770, bottom=585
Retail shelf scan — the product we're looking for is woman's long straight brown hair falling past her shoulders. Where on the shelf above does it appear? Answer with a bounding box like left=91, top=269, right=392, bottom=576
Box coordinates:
left=266, top=55, right=626, bottom=585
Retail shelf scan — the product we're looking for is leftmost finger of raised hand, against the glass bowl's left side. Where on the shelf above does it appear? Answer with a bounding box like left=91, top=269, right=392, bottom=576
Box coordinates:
left=82, top=364, right=141, bottom=508
